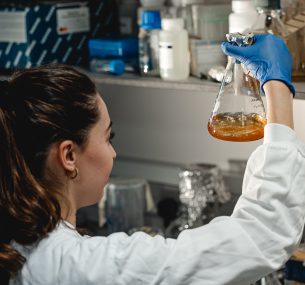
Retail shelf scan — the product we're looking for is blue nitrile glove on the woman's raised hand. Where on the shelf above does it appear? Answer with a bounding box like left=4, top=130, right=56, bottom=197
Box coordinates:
left=221, top=34, right=295, bottom=96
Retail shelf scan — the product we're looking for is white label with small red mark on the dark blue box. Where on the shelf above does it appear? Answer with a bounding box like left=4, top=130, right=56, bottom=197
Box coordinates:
left=57, top=7, right=90, bottom=35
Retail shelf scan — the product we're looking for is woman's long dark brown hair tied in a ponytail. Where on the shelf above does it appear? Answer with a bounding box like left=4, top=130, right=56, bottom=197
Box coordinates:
left=0, top=65, right=99, bottom=284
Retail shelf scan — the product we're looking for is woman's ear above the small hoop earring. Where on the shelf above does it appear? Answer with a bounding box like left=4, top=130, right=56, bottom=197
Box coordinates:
left=58, top=140, right=77, bottom=172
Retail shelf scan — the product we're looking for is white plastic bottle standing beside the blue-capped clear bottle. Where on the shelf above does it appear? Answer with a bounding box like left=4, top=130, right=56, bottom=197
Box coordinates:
left=159, top=18, right=190, bottom=80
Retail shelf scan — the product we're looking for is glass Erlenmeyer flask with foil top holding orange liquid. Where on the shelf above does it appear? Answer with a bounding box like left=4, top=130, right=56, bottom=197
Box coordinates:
left=208, top=33, right=267, bottom=142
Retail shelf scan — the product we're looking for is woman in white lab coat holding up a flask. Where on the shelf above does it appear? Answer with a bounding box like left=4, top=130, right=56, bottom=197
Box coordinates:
left=0, top=35, right=305, bottom=285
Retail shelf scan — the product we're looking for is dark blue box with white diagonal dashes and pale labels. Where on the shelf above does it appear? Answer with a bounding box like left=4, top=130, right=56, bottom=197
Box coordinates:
left=0, top=0, right=119, bottom=69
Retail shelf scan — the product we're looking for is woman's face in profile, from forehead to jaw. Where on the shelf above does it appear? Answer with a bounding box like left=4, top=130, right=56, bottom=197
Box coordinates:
left=75, top=96, right=116, bottom=208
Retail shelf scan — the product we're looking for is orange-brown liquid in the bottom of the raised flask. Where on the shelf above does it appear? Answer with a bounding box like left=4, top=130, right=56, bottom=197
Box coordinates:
left=208, top=112, right=267, bottom=142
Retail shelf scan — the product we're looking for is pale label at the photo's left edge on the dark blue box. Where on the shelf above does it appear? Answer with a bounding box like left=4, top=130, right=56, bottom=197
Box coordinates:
left=0, top=11, right=27, bottom=43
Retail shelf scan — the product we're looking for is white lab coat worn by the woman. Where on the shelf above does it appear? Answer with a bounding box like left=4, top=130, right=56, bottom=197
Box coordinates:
left=10, top=124, right=305, bottom=285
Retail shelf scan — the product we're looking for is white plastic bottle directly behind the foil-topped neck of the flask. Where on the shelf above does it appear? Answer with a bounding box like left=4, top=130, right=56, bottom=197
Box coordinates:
left=229, top=0, right=259, bottom=33
